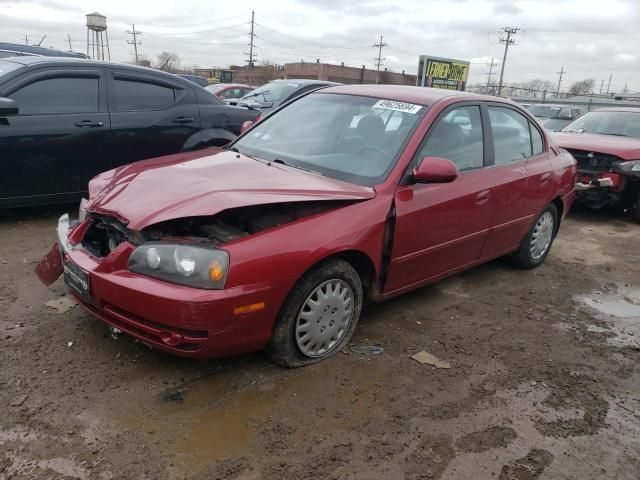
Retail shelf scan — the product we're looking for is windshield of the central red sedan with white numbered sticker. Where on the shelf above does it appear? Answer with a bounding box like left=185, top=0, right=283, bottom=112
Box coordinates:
left=233, top=93, right=427, bottom=186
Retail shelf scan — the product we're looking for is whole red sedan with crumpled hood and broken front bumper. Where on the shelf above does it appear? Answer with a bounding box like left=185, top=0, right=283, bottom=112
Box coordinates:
left=37, top=86, right=576, bottom=366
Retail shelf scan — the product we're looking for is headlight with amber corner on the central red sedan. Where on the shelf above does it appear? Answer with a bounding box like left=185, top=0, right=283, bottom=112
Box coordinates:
left=128, top=242, right=229, bottom=289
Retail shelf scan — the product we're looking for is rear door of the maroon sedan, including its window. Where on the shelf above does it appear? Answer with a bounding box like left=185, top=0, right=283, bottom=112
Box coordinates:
left=482, top=104, right=550, bottom=257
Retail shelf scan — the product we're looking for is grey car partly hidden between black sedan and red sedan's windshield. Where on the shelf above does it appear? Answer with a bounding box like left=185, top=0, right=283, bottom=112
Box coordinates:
left=229, top=79, right=340, bottom=116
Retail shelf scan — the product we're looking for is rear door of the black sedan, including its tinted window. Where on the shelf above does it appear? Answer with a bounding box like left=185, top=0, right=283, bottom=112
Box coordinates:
left=109, top=69, right=201, bottom=167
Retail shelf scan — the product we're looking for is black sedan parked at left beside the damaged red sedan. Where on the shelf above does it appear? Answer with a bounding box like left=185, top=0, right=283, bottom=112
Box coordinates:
left=0, top=57, right=259, bottom=208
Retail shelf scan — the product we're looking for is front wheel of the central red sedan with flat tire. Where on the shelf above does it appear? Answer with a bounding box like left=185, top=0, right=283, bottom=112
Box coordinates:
left=266, top=258, right=363, bottom=367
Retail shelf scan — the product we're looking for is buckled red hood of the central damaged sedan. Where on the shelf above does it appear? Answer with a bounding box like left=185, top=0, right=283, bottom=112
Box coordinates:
left=87, top=148, right=375, bottom=230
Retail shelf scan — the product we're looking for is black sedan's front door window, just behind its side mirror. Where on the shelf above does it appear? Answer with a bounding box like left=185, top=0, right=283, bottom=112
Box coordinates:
left=9, top=77, right=99, bottom=115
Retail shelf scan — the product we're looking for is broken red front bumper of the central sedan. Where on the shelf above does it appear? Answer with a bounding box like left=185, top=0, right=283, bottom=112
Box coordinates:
left=36, top=214, right=295, bottom=358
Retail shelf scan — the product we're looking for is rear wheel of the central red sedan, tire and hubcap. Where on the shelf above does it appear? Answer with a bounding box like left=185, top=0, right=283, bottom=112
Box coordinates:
left=511, top=204, right=558, bottom=269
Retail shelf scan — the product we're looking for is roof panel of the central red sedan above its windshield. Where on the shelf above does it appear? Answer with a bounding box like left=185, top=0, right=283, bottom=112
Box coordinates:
left=320, top=85, right=500, bottom=105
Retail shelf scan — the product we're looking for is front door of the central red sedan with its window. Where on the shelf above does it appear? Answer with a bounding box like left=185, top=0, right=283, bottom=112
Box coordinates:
left=385, top=103, right=493, bottom=293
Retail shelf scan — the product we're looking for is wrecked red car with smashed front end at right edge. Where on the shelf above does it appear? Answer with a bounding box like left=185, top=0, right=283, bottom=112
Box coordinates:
left=553, top=107, right=640, bottom=222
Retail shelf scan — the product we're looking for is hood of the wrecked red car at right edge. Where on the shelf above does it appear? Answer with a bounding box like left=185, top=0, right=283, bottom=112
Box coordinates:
left=551, top=132, right=640, bottom=160
